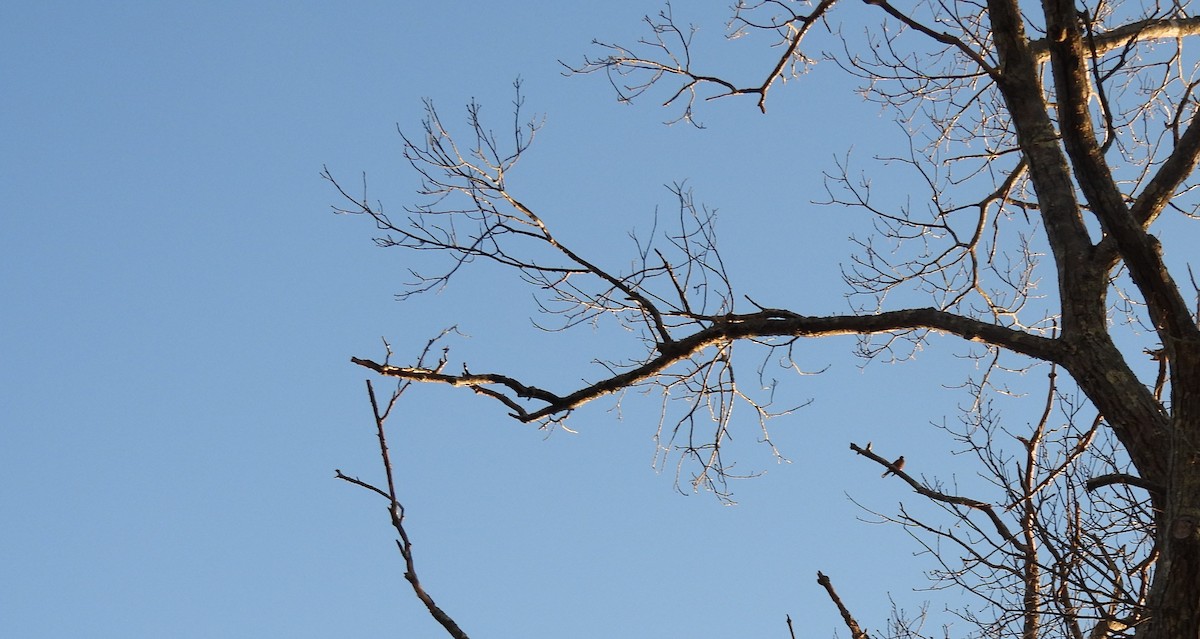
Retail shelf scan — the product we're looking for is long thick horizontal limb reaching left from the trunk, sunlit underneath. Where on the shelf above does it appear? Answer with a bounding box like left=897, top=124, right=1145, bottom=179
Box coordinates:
left=350, top=309, right=1063, bottom=423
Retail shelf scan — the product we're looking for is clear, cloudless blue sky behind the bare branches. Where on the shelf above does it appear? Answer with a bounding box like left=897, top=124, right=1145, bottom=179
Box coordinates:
left=7, top=1, right=1180, bottom=638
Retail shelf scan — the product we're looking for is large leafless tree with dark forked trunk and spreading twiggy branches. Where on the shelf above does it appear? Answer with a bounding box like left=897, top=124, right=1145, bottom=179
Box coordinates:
left=325, top=0, right=1200, bottom=639
